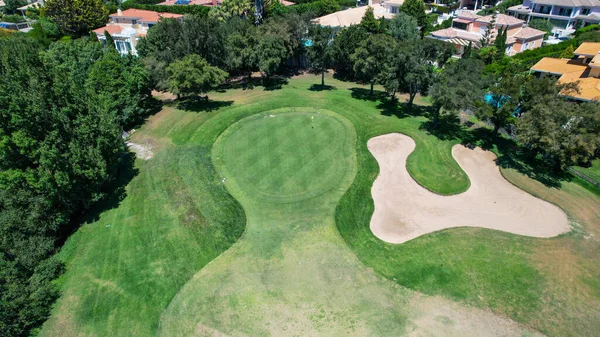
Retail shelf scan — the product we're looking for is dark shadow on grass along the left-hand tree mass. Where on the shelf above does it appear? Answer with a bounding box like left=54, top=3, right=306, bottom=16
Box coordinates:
left=57, top=149, right=139, bottom=246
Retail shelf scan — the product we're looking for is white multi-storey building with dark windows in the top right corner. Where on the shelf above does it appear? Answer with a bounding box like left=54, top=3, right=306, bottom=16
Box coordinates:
left=507, top=0, right=600, bottom=37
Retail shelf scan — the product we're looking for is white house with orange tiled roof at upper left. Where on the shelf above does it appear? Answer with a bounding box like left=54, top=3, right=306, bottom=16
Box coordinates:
left=94, top=8, right=183, bottom=55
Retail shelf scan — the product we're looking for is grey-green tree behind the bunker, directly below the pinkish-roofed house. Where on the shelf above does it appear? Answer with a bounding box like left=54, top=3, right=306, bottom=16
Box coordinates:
left=429, top=58, right=483, bottom=128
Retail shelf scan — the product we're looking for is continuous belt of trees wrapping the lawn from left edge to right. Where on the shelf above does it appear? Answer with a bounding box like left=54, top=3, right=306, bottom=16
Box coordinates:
left=0, top=0, right=600, bottom=336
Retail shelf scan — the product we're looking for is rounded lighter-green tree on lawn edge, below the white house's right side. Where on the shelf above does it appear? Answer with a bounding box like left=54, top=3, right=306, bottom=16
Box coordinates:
left=167, top=54, right=227, bottom=101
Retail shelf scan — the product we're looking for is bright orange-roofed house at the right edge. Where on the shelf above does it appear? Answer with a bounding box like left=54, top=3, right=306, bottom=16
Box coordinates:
left=531, top=42, right=600, bottom=101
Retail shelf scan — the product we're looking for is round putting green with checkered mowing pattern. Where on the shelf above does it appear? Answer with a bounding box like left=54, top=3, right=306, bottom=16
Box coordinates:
left=217, top=110, right=348, bottom=202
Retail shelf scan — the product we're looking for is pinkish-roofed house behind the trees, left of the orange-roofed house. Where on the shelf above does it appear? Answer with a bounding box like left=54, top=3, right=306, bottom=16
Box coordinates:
left=428, top=11, right=545, bottom=56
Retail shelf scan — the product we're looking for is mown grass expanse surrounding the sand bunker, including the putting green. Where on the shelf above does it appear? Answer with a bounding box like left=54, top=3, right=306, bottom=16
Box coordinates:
left=41, top=76, right=600, bottom=336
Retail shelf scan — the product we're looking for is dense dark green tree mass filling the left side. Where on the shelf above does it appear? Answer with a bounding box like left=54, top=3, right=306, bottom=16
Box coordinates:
left=0, top=34, right=150, bottom=336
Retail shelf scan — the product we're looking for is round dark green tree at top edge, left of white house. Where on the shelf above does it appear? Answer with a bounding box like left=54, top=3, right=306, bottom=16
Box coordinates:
left=42, top=0, right=108, bottom=36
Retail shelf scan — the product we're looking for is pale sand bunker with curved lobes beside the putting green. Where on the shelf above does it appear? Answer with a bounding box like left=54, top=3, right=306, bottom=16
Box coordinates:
left=368, top=133, right=570, bottom=243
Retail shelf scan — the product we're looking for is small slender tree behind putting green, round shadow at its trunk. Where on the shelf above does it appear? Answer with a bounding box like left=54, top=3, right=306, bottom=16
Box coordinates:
left=308, top=25, right=333, bottom=86
